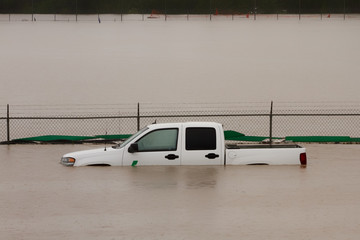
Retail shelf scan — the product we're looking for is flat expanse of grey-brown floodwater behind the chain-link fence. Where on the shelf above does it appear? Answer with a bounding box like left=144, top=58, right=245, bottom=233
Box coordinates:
left=0, top=18, right=360, bottom=105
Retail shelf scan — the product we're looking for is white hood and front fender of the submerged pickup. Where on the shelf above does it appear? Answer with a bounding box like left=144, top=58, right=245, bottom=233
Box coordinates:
left=63, top=147, right=124, bottom=166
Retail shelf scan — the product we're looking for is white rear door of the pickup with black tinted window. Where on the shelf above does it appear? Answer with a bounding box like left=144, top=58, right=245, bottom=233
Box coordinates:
left=181, top=127, right=224, bottom=165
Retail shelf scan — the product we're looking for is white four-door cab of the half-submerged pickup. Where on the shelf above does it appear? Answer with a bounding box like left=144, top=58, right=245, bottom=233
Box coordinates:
left=122, top=123, right=224, bottom=166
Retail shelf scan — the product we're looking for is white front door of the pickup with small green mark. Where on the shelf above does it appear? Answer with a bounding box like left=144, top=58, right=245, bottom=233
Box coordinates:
left=123, top=128, right=181, bottom=166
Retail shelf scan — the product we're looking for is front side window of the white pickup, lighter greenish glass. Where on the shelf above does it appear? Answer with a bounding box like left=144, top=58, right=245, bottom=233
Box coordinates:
left=137, top=128, right=178, bottom=152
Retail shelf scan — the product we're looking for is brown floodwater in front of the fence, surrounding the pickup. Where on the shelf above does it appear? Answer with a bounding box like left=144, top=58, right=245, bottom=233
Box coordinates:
left=0, top=144, right=360, bottom=240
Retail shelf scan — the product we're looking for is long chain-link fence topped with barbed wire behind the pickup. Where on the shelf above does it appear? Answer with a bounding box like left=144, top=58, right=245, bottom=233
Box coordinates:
left=0, top=102, right=360, bottom=143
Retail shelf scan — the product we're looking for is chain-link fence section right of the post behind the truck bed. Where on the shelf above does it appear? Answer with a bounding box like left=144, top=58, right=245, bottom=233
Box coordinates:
left=273, top=103, right=360, bottom=137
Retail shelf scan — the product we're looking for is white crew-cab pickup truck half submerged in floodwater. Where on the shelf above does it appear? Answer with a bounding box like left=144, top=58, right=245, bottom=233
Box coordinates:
left=61, top=122, right=306, bottom=166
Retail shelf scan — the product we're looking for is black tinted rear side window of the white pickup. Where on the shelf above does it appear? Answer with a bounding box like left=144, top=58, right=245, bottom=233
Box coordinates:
left=186, top=128, right=216, bottom=150
